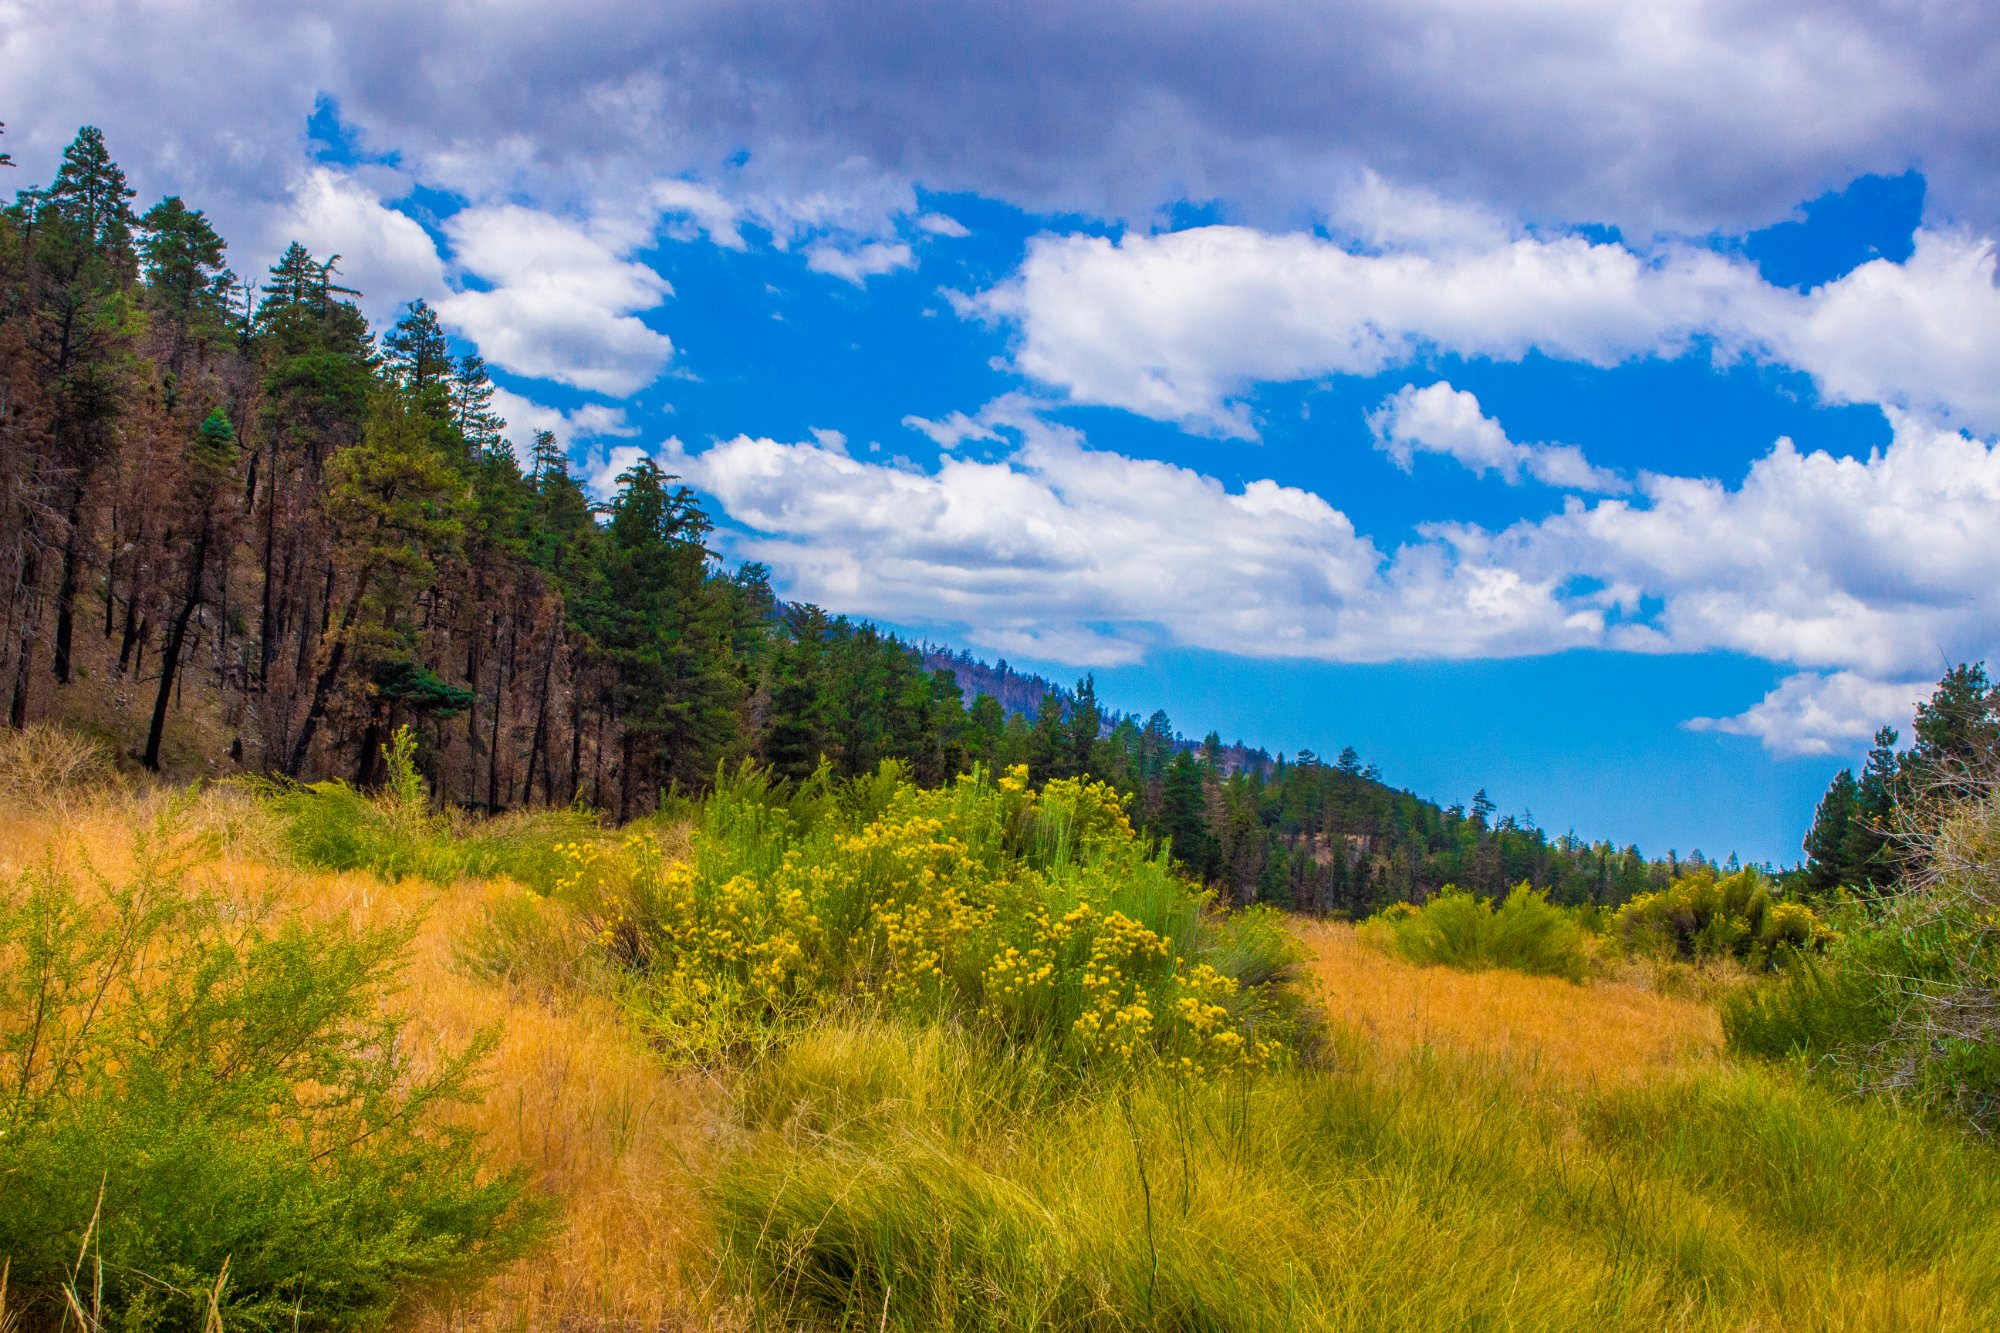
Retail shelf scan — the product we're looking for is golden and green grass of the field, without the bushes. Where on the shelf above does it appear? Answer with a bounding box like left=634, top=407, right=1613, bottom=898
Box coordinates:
left=0, top=752, right=2000, bottom=1333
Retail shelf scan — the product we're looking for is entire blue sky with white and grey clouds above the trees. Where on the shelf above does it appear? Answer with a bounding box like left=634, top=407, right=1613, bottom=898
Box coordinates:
left=0, top=0, right=2000, bottom=863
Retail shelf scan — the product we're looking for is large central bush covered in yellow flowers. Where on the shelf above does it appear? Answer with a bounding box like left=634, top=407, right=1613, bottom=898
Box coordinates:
left=556, top=765, right=1304, bottom=1075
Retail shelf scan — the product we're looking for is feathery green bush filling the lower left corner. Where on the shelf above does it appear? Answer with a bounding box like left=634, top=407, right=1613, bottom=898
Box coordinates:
left=0, top=792, right=544, bottom=1329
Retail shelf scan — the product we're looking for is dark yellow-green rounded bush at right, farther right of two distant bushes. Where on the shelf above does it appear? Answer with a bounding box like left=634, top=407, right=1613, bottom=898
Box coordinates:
left=1612, top=867, right=1826, bottom=969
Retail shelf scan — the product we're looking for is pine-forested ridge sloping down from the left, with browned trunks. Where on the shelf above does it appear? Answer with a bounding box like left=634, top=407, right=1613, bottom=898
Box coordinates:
left=0, top=128, right=1712, bottom=913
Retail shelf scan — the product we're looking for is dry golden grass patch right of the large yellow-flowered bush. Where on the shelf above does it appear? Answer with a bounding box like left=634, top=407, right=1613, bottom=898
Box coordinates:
left=1292, top=919, right=1722, bottom=1081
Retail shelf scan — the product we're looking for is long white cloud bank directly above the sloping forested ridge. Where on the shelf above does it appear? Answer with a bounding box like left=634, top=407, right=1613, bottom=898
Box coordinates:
left=662, top=404, right=1602, bottom=662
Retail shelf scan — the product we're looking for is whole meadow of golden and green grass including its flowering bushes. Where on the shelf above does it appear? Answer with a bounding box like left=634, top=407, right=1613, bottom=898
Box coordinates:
left=0, top=737, right=2000, bottom=1331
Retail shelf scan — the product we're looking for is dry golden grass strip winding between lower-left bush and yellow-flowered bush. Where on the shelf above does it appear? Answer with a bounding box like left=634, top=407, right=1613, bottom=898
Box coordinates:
left=0, top=791, right=732, bottom=1331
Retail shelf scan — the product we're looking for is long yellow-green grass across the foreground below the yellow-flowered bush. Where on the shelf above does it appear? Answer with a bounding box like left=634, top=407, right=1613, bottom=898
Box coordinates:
left=712, top=1012, right=2000, bottom=1331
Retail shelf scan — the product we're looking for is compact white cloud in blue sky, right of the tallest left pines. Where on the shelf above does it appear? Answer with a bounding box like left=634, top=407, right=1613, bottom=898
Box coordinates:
left=438, top=204, right=674, bottom=396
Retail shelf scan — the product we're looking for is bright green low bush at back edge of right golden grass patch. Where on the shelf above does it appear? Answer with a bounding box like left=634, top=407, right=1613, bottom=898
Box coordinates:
left=1362, top=885, right=1590, bottom=981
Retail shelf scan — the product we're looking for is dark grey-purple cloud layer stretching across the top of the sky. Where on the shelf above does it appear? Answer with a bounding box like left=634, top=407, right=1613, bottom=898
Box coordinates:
left=15, top=0, right=2000, bottom=304
